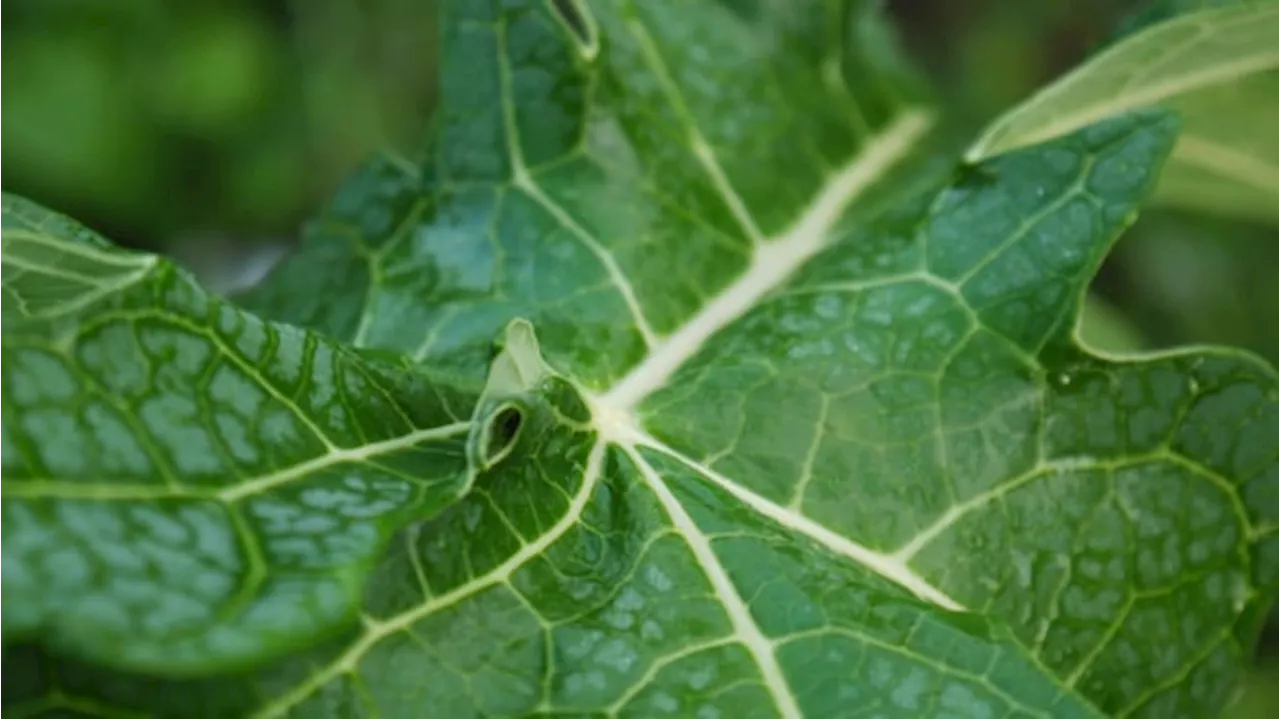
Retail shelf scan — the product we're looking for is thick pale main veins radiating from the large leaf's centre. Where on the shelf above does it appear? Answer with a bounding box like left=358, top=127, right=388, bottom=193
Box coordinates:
left=255, top=104, right=963, bottom=719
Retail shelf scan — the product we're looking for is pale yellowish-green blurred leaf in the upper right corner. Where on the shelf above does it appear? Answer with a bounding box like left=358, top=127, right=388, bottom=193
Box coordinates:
left=969, top=0, right=1280, bottom=223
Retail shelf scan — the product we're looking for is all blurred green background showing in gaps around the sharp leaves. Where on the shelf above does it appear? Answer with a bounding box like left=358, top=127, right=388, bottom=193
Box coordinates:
left=0, top=0, right=1280, bottom=719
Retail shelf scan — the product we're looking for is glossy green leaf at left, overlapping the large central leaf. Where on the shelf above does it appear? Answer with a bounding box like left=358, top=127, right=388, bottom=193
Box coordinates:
left=0, top=196, right=475, bottom=674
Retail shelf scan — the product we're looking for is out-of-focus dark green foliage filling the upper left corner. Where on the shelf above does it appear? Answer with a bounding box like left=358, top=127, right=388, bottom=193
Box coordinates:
left=0, top=0, right=435, bottom=254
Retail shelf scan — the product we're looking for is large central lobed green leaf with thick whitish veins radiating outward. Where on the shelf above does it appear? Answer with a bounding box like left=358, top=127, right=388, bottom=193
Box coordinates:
left=0, top=0, right=1280, bottom=718
